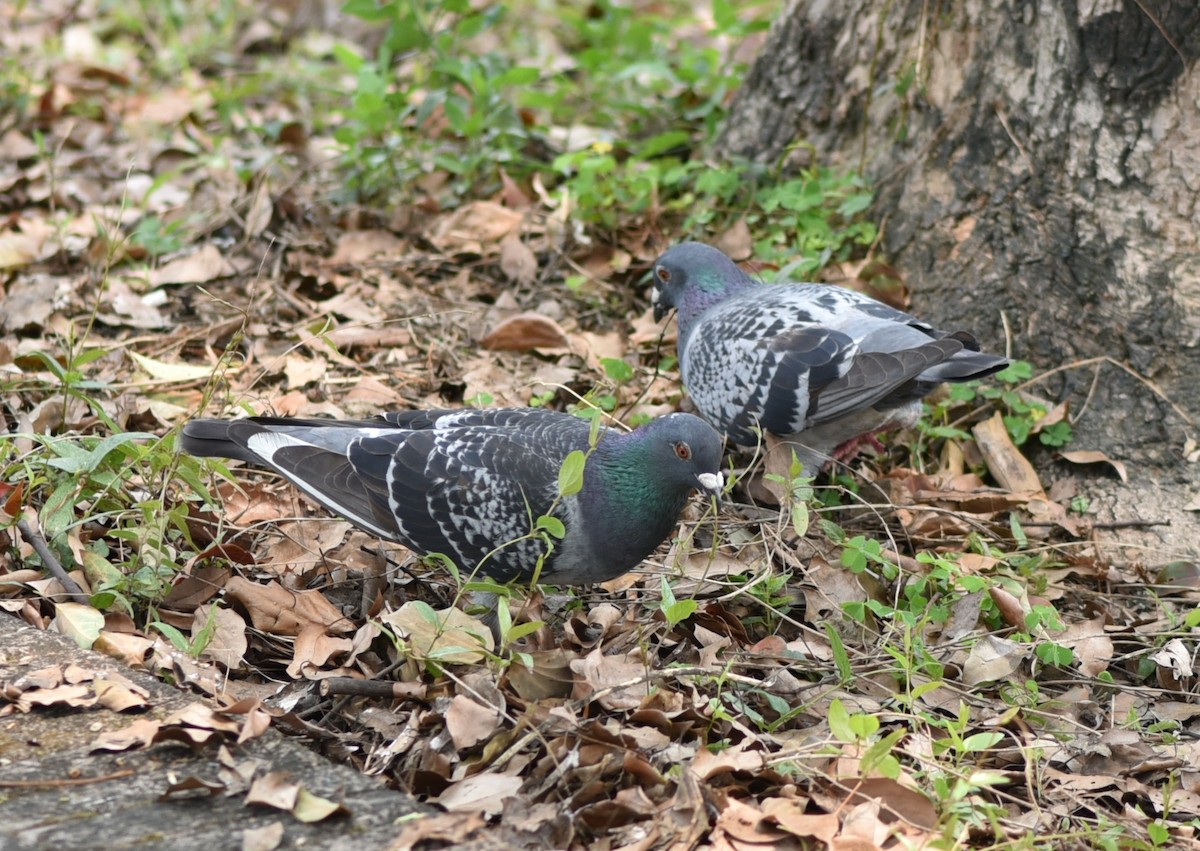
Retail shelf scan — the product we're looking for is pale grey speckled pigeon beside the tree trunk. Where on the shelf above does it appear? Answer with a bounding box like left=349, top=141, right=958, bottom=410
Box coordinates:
left=650, top=242, right=1008, bottom=474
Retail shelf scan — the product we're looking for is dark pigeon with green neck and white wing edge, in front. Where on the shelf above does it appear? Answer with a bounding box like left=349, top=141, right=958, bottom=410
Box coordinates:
left=181, top=408, right=724, bottom=585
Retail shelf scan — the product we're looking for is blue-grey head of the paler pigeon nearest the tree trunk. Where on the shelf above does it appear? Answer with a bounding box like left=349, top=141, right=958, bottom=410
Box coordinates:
left=650, top=242, right=754, bottom=323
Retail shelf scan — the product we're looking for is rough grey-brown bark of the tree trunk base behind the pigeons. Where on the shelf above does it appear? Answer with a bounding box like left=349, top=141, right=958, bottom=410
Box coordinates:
left=722, top=0, right=1200, bottom=478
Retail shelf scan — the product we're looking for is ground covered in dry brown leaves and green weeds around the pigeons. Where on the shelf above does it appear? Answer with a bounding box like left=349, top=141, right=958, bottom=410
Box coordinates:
left=0, top=0, right=1200, bottom=849
